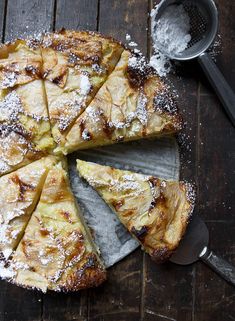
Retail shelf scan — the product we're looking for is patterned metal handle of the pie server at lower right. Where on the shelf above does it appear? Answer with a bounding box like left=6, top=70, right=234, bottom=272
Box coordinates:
left=200, top=248, right=235, bottom=286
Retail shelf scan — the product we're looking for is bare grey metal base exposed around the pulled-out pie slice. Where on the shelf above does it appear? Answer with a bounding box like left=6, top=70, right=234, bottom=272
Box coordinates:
left=68, top=137, right=180, bottom=267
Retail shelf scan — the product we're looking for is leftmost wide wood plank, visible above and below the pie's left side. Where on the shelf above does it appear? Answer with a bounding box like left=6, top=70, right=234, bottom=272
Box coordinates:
left=0, top=0, right=53, bottom=321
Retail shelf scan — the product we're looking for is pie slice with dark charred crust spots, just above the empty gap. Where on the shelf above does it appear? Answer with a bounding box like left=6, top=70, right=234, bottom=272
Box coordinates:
left=63, top=50, right=182, bottom=154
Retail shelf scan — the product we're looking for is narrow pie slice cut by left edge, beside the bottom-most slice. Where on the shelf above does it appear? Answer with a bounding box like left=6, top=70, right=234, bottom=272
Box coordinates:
left=0, top=156, right=57, bottom=261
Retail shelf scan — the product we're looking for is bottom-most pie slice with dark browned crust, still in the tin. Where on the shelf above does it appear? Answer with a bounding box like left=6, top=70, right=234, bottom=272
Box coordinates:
left=12, top=159, right=106, bottom=292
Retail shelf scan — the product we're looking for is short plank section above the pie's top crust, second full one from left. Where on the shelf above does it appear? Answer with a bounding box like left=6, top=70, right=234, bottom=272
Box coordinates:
left=55, top=0, right=98, bottom=31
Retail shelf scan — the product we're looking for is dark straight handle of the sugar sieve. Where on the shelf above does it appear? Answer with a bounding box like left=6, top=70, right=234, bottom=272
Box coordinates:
left=198, top=53, right=235, bottom=126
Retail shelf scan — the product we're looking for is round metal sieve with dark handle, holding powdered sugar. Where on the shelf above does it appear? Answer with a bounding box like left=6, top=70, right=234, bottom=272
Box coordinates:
left=152, top=0, right=235, bottom=126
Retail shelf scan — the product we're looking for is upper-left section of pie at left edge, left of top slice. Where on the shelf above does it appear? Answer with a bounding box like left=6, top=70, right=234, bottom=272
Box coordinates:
left=0, top=40, right=54, bottom=175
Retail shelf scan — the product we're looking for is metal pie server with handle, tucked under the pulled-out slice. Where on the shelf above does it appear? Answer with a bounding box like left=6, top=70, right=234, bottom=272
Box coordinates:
left=170, top=215, right=235, bottom=286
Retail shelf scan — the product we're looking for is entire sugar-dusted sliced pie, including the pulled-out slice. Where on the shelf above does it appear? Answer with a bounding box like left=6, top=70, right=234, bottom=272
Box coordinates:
left=0, top=30, right=193, bottom=292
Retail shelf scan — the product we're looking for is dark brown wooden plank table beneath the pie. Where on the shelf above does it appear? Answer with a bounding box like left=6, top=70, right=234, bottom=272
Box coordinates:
left=0, top=0, right=235, bottom=321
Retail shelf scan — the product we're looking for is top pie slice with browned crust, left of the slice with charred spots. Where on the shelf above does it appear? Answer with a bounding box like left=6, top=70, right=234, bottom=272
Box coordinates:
left=42, top=30, right=123, bottom=146
